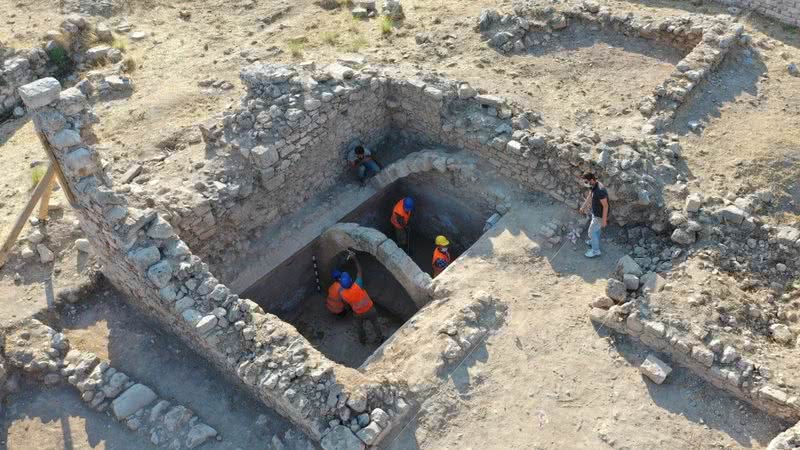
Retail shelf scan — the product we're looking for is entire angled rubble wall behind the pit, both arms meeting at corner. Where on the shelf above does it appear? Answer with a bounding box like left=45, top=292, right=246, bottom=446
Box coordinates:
left=172, top=59, right=683, bottom=264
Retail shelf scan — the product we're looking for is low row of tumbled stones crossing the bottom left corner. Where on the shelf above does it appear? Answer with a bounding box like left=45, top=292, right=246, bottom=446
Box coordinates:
left=3, top=319, right=219, bottom=449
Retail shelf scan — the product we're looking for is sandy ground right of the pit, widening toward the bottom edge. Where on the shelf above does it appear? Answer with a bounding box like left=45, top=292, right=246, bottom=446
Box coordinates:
left=388, top=200, right=787, bottom=450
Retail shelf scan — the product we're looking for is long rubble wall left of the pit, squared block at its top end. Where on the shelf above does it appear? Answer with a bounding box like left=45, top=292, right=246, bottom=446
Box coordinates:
left=20, top=78, right=410, bottom=448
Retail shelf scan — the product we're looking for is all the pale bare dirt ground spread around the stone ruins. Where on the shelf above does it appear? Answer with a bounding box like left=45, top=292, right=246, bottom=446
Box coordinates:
left=0, top=0, right=800, bottom=449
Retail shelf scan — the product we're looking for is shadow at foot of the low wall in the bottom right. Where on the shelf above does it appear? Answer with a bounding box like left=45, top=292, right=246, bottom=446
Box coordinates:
left=592, top=322, right=791, bottom=448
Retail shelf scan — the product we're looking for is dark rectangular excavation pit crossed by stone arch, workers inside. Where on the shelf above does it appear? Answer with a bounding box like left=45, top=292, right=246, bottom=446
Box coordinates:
left=242, top=175, right=493, bottom=367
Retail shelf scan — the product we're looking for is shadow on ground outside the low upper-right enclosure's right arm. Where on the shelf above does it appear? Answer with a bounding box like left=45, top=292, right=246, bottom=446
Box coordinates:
left=669, top=46, right=767, bottom=136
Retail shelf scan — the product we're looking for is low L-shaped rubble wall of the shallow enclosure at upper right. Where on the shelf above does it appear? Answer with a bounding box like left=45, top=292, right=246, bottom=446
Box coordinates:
left=478, top=0, right=749, bottom=133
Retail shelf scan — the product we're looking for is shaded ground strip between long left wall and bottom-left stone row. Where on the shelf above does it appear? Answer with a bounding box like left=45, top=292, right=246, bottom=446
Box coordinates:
left=49, top=281, right=292, bottom=448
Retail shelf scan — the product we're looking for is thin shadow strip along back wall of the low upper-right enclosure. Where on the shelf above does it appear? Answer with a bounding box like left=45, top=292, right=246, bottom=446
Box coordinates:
left=495, top=21, right=689, bottom=62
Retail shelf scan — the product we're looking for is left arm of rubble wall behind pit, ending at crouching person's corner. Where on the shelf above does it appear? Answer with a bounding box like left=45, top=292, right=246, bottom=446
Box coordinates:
left=168, top=64, right=389, bottom=268
